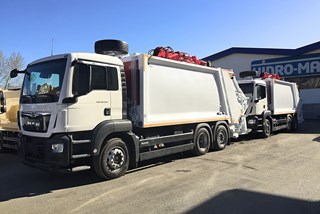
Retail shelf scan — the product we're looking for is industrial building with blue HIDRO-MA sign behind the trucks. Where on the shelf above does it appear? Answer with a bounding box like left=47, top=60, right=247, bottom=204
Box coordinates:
left=203, top=41, right=320, bottom=119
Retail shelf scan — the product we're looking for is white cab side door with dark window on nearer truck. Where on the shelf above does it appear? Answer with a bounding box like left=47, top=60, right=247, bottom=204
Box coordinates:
left=67, top=63, right=121, bottom=131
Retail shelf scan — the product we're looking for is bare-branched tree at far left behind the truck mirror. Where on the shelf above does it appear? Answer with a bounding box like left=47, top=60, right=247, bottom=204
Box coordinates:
left=0, top=51, right=23, bottom=89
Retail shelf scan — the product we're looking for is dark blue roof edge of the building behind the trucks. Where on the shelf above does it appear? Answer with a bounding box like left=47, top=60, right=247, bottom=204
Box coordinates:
left=203, top=41, right=320, bottom=61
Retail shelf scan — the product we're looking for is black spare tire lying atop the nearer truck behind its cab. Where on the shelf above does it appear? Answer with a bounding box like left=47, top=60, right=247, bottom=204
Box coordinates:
left=94, top=39, right=128, bottom=56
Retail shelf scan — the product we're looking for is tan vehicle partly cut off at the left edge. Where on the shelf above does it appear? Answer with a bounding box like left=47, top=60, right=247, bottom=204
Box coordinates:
left=0, top=89, right=20, bottom=152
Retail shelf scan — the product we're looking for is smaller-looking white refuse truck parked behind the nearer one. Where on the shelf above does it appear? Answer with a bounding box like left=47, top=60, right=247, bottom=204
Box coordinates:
left=238, top=71, right=303, bottom=137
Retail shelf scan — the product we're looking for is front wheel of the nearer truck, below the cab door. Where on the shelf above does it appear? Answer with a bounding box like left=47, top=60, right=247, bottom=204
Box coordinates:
left=93, top=138, right=129, bottom=179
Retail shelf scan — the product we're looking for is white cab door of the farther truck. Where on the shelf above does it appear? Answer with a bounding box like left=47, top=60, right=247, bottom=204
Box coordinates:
left=254, top=84, right=268, bottom=115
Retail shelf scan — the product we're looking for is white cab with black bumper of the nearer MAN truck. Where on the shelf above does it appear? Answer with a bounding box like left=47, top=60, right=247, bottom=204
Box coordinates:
left=13, top=53, right=131, bottom=171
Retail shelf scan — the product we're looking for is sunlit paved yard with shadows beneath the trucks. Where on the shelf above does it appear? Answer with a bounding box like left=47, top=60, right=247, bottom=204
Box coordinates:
left=0, top=121, right=320, bottom=214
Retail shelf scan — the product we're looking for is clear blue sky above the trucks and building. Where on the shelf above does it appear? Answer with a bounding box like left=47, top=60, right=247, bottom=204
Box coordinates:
left=0, top=0, right=320, bottom=65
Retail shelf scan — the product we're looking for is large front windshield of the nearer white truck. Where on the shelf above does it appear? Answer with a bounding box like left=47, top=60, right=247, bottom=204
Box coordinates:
left=20, top=58, right=67, bottom=103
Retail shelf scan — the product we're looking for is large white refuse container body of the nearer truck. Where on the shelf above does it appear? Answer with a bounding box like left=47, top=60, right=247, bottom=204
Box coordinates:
left=122, top=54, right=243, bottom=128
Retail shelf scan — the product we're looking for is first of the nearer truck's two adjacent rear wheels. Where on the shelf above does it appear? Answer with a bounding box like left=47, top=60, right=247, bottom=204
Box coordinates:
left=193, top=128, right=211, bottom=156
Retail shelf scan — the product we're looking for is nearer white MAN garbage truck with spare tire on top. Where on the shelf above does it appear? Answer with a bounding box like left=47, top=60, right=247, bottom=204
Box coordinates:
left=11, top=40, right=300, bottom=179
